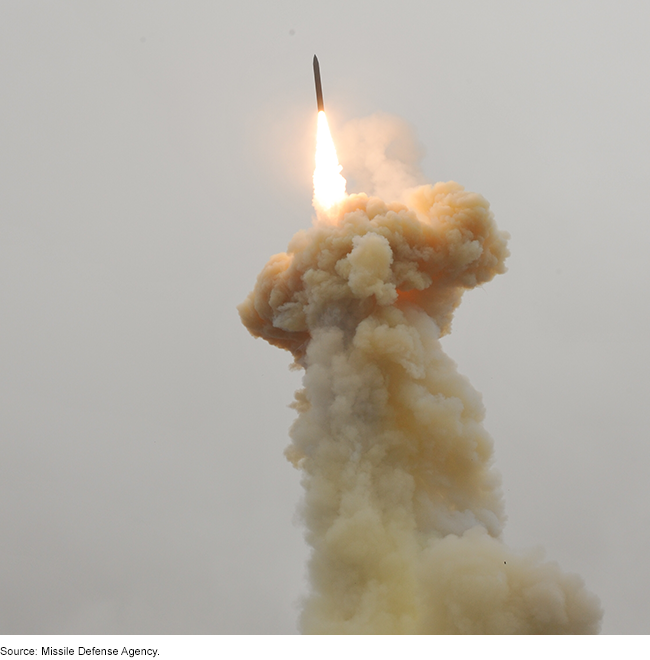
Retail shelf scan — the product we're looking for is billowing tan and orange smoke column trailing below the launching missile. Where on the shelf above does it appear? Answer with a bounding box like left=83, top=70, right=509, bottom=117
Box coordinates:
left=239, top=114, right=602, bottom=634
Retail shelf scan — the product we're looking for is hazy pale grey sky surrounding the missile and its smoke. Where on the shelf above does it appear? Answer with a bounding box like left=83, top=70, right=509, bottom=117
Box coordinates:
left=0, top=0, right=650, bottom=633
